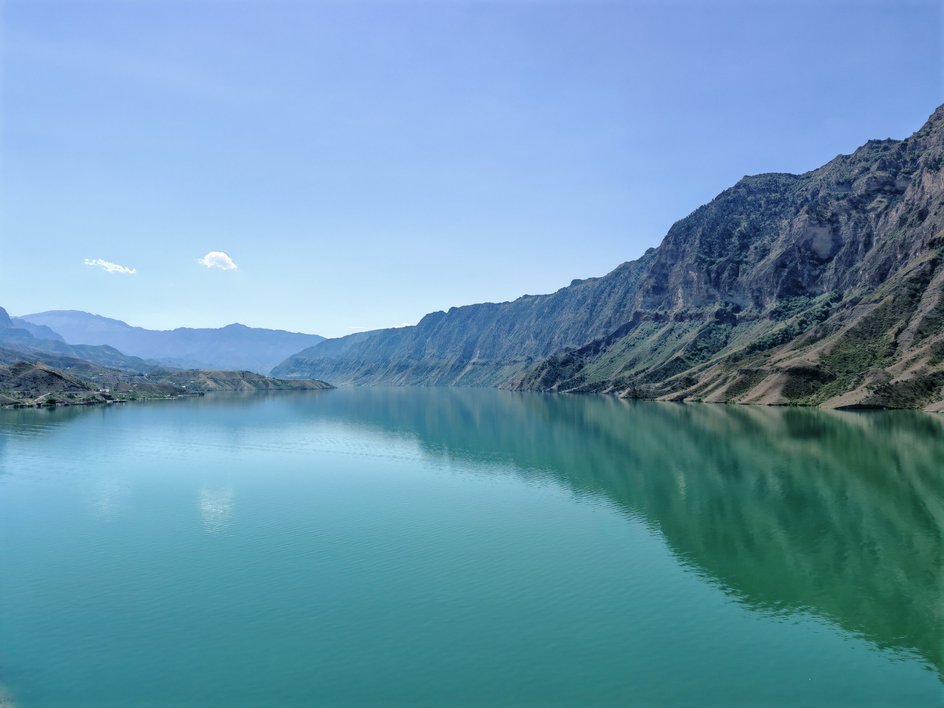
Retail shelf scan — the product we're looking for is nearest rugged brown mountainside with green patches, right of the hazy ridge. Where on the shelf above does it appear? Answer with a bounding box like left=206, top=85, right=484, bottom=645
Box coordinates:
left=506, top=103, right=944, bottom=409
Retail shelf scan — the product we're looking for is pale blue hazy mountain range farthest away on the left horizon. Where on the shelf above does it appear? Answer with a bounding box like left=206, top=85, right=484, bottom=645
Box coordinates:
left=18, top=310, right=324, bottom=373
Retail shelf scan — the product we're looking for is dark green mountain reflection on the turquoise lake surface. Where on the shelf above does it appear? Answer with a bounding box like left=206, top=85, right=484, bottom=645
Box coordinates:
left=0, top=388, right=944, bottom=675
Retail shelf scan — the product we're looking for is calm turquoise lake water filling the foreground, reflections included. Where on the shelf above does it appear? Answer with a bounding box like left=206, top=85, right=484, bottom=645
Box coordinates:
left=0, top=389, right=944, bottom=706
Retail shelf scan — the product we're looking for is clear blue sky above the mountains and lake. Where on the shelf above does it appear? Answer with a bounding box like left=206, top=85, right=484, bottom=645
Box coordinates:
left=0, top=0, right=944, bottom=336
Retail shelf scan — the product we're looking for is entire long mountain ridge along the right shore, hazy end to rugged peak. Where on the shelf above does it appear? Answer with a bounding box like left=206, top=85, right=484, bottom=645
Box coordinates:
left=272, top=106, right=944, bottom=410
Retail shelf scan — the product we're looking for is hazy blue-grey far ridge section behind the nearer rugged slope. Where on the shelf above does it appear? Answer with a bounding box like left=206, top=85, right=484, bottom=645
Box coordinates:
left=272, top=255, right=650, bottom=386
